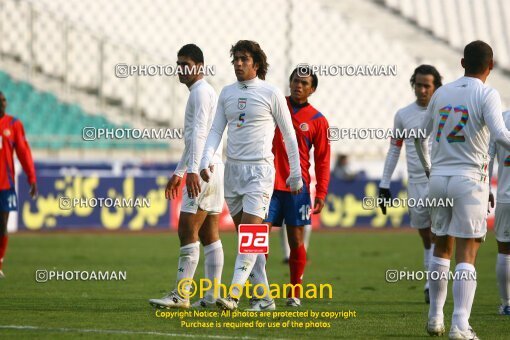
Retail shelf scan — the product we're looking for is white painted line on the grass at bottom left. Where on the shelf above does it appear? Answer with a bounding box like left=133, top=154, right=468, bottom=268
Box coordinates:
left=0, top=325, right=274, bottom=339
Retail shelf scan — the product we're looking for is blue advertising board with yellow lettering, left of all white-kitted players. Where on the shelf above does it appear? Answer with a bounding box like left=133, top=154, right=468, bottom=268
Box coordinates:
left=18, top=175, right=171, bottom=231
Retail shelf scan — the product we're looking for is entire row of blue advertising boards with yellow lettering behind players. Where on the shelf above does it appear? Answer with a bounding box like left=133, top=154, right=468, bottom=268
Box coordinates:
left=17, top=174, right=493, bottom=231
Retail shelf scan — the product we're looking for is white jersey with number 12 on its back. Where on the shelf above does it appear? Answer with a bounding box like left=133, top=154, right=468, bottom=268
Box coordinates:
left=422, top=77, right=510, bottom=182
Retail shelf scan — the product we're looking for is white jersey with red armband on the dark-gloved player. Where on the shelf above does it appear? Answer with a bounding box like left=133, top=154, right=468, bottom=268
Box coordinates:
left=380, top=102, right=429, bottom=188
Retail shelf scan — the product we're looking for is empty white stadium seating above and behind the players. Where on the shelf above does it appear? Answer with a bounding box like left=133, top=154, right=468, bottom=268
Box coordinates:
left=0, top=0, right=510, bottom=163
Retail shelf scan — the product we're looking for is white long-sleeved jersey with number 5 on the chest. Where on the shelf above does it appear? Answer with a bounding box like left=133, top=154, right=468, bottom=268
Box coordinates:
left=200, top=78, right=301, bottom=177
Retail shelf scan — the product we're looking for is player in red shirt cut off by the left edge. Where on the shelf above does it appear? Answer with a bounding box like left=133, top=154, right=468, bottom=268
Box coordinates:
left=0, top=92, right=37, bottom=279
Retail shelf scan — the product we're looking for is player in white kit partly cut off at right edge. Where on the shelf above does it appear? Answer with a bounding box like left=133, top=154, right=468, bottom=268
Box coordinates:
left=489, top=111, right=510, bottom=315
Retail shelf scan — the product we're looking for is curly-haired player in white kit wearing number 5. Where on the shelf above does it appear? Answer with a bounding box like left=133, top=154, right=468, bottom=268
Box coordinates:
left=200, top=40, right=303, bottom=310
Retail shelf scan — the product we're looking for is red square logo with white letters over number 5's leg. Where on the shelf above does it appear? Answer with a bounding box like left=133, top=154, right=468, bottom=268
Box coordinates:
left=238, top=224, right=269, bottom=254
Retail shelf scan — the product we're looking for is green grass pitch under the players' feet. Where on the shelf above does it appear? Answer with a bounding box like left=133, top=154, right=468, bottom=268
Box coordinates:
left=0, top=231, right=510, bottom=339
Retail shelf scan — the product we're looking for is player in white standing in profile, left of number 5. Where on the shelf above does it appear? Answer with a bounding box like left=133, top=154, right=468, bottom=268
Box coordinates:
left=149, top=44, right=223, bottom=308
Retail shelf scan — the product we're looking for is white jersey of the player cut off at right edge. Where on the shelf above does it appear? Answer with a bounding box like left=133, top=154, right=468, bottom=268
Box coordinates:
left=489, top=111, right=510, bottom=203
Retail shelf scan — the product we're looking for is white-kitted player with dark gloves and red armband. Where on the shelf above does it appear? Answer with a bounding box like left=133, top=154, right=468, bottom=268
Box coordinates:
left=379, top=65, right=442, bottom=303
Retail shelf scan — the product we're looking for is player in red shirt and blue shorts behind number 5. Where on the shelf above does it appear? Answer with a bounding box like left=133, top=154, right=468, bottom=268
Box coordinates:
left=251, top=66, right=330, bottom=307
